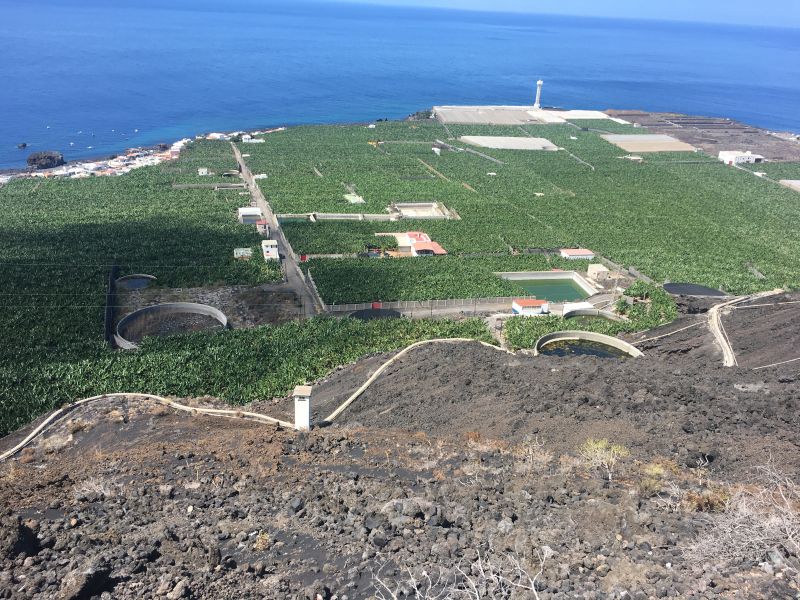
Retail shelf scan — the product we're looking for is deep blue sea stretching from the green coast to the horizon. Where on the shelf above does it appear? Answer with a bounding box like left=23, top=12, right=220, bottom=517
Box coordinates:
left=0, top=0, right=800, bottom=168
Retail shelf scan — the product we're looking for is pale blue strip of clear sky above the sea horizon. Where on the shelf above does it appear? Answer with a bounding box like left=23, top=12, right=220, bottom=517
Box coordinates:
left=338, top=0, right=800, bottom=28
